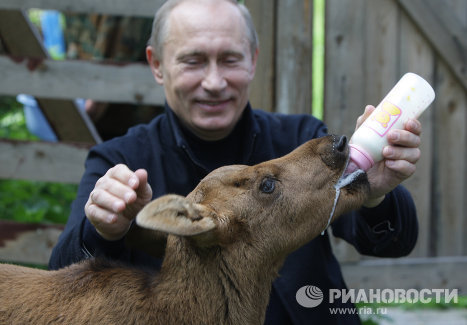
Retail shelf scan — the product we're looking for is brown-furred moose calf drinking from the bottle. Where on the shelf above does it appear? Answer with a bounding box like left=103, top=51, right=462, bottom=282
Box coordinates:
left=0, top=136, right=368, bottom=325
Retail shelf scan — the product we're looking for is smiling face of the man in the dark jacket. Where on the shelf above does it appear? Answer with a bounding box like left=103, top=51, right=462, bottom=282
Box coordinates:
left=147, top=1, right=257, bottom=140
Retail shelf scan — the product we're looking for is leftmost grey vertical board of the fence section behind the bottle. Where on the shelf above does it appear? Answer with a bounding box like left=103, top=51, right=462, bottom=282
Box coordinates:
left=324, top=0, right=367, bottom=262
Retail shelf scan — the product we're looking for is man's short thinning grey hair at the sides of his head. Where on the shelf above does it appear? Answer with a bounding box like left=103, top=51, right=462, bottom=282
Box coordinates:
left=148, top=0, right=259, bottom=61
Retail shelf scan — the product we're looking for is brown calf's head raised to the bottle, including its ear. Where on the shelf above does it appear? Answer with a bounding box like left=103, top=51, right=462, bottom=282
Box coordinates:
left=136, top=136, right=369, bottom=256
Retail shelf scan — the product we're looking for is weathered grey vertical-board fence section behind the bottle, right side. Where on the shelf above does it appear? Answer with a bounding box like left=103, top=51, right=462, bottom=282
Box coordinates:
left=325, top=0, right=467, bottom=264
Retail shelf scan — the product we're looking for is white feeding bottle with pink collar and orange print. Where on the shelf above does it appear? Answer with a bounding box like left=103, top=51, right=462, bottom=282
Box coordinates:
left=347, top=72, right=435, bottom=173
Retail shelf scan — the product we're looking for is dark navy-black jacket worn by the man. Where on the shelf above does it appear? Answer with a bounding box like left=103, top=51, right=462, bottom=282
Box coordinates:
left=49, top=106, right=418, bottom=325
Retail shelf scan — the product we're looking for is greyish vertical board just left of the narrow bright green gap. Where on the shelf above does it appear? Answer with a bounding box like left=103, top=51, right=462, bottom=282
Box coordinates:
left=275, top=0, right=313, bottom=114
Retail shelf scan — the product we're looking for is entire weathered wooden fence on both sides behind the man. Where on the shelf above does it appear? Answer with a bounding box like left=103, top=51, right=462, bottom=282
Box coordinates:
left=0, top=0, right=467, bottom=292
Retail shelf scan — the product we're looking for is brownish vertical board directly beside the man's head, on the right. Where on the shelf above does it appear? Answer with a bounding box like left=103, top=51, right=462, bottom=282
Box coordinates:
left=246, top=1, right=275, bottom=111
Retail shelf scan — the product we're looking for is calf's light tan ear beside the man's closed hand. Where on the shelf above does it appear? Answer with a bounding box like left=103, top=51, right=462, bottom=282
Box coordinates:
left=136, top=194, right=216, bottom=239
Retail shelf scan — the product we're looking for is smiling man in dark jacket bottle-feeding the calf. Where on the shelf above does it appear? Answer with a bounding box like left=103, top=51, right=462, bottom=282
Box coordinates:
left=50, top=0, right=421, bottom=324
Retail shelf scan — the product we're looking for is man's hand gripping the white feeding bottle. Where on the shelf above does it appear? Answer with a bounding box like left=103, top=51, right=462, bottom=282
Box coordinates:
left=357, top=105, right=422, bottom=207
